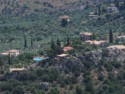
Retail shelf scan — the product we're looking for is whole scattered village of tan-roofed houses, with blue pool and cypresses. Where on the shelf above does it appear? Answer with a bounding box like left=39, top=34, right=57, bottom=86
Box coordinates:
left=0, top=6, right=125, bottom=73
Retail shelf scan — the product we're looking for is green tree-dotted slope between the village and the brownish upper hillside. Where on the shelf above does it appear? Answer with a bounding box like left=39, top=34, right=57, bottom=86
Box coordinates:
left=0, top=1, right=125, bottom=51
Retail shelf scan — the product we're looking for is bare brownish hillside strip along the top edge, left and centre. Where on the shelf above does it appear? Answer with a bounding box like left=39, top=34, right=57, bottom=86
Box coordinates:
left=0, top=0, right=83, bottom=12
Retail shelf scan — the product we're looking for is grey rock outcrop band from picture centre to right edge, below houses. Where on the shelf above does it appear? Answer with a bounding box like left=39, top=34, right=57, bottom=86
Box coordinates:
left=51, top=48, right=125, bottom=72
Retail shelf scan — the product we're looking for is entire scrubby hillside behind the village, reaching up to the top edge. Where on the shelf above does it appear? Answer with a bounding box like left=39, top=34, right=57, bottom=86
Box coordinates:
left=0, top=0, right=125, bottom=51
